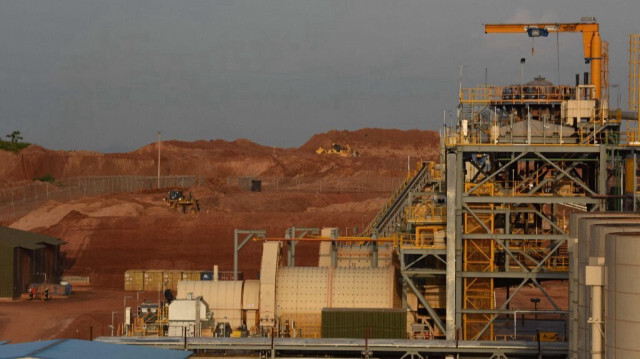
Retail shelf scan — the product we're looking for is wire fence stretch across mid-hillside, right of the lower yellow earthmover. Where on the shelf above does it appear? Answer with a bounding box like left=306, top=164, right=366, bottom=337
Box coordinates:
left=227, top=176, right=405, bottom=193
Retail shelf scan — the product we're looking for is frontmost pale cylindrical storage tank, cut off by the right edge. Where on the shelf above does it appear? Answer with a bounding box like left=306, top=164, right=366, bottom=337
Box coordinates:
left=605, top=233, right=640, bottom=359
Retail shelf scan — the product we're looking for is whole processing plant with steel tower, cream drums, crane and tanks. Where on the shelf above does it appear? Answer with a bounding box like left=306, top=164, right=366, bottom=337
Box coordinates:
left=99, top=18, right=640, bottom=358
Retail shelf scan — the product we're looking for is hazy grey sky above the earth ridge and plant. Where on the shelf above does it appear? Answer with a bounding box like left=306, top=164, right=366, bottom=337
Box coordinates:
left=0, top=0, right=640, bottom=152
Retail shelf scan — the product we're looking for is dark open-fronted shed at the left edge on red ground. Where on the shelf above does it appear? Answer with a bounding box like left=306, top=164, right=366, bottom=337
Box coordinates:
left=0, top=226, right=65, bottom=299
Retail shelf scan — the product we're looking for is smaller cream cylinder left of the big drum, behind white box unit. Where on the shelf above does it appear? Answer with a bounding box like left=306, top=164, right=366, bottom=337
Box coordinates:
left=177, top=280, right=243, bottom=329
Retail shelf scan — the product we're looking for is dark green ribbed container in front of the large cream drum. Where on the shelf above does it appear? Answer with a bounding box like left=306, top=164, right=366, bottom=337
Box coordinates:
left=322, top=308, right=407, bottom=339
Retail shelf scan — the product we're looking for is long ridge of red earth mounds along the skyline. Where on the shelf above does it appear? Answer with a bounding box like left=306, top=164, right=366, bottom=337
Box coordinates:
left=0, top=129, right=439, bottom=184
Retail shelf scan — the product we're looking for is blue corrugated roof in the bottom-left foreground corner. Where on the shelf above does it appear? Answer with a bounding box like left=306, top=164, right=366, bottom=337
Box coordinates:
left=0, top=339, right=193, bottom=359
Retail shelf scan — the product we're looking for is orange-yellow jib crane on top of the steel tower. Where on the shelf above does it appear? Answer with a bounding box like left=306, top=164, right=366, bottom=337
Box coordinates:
left=484, top=18, right=602, bottom=100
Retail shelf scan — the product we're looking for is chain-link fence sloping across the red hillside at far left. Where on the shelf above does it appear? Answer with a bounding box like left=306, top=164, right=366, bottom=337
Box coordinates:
left=0, top=176, right=204, bottom=220
